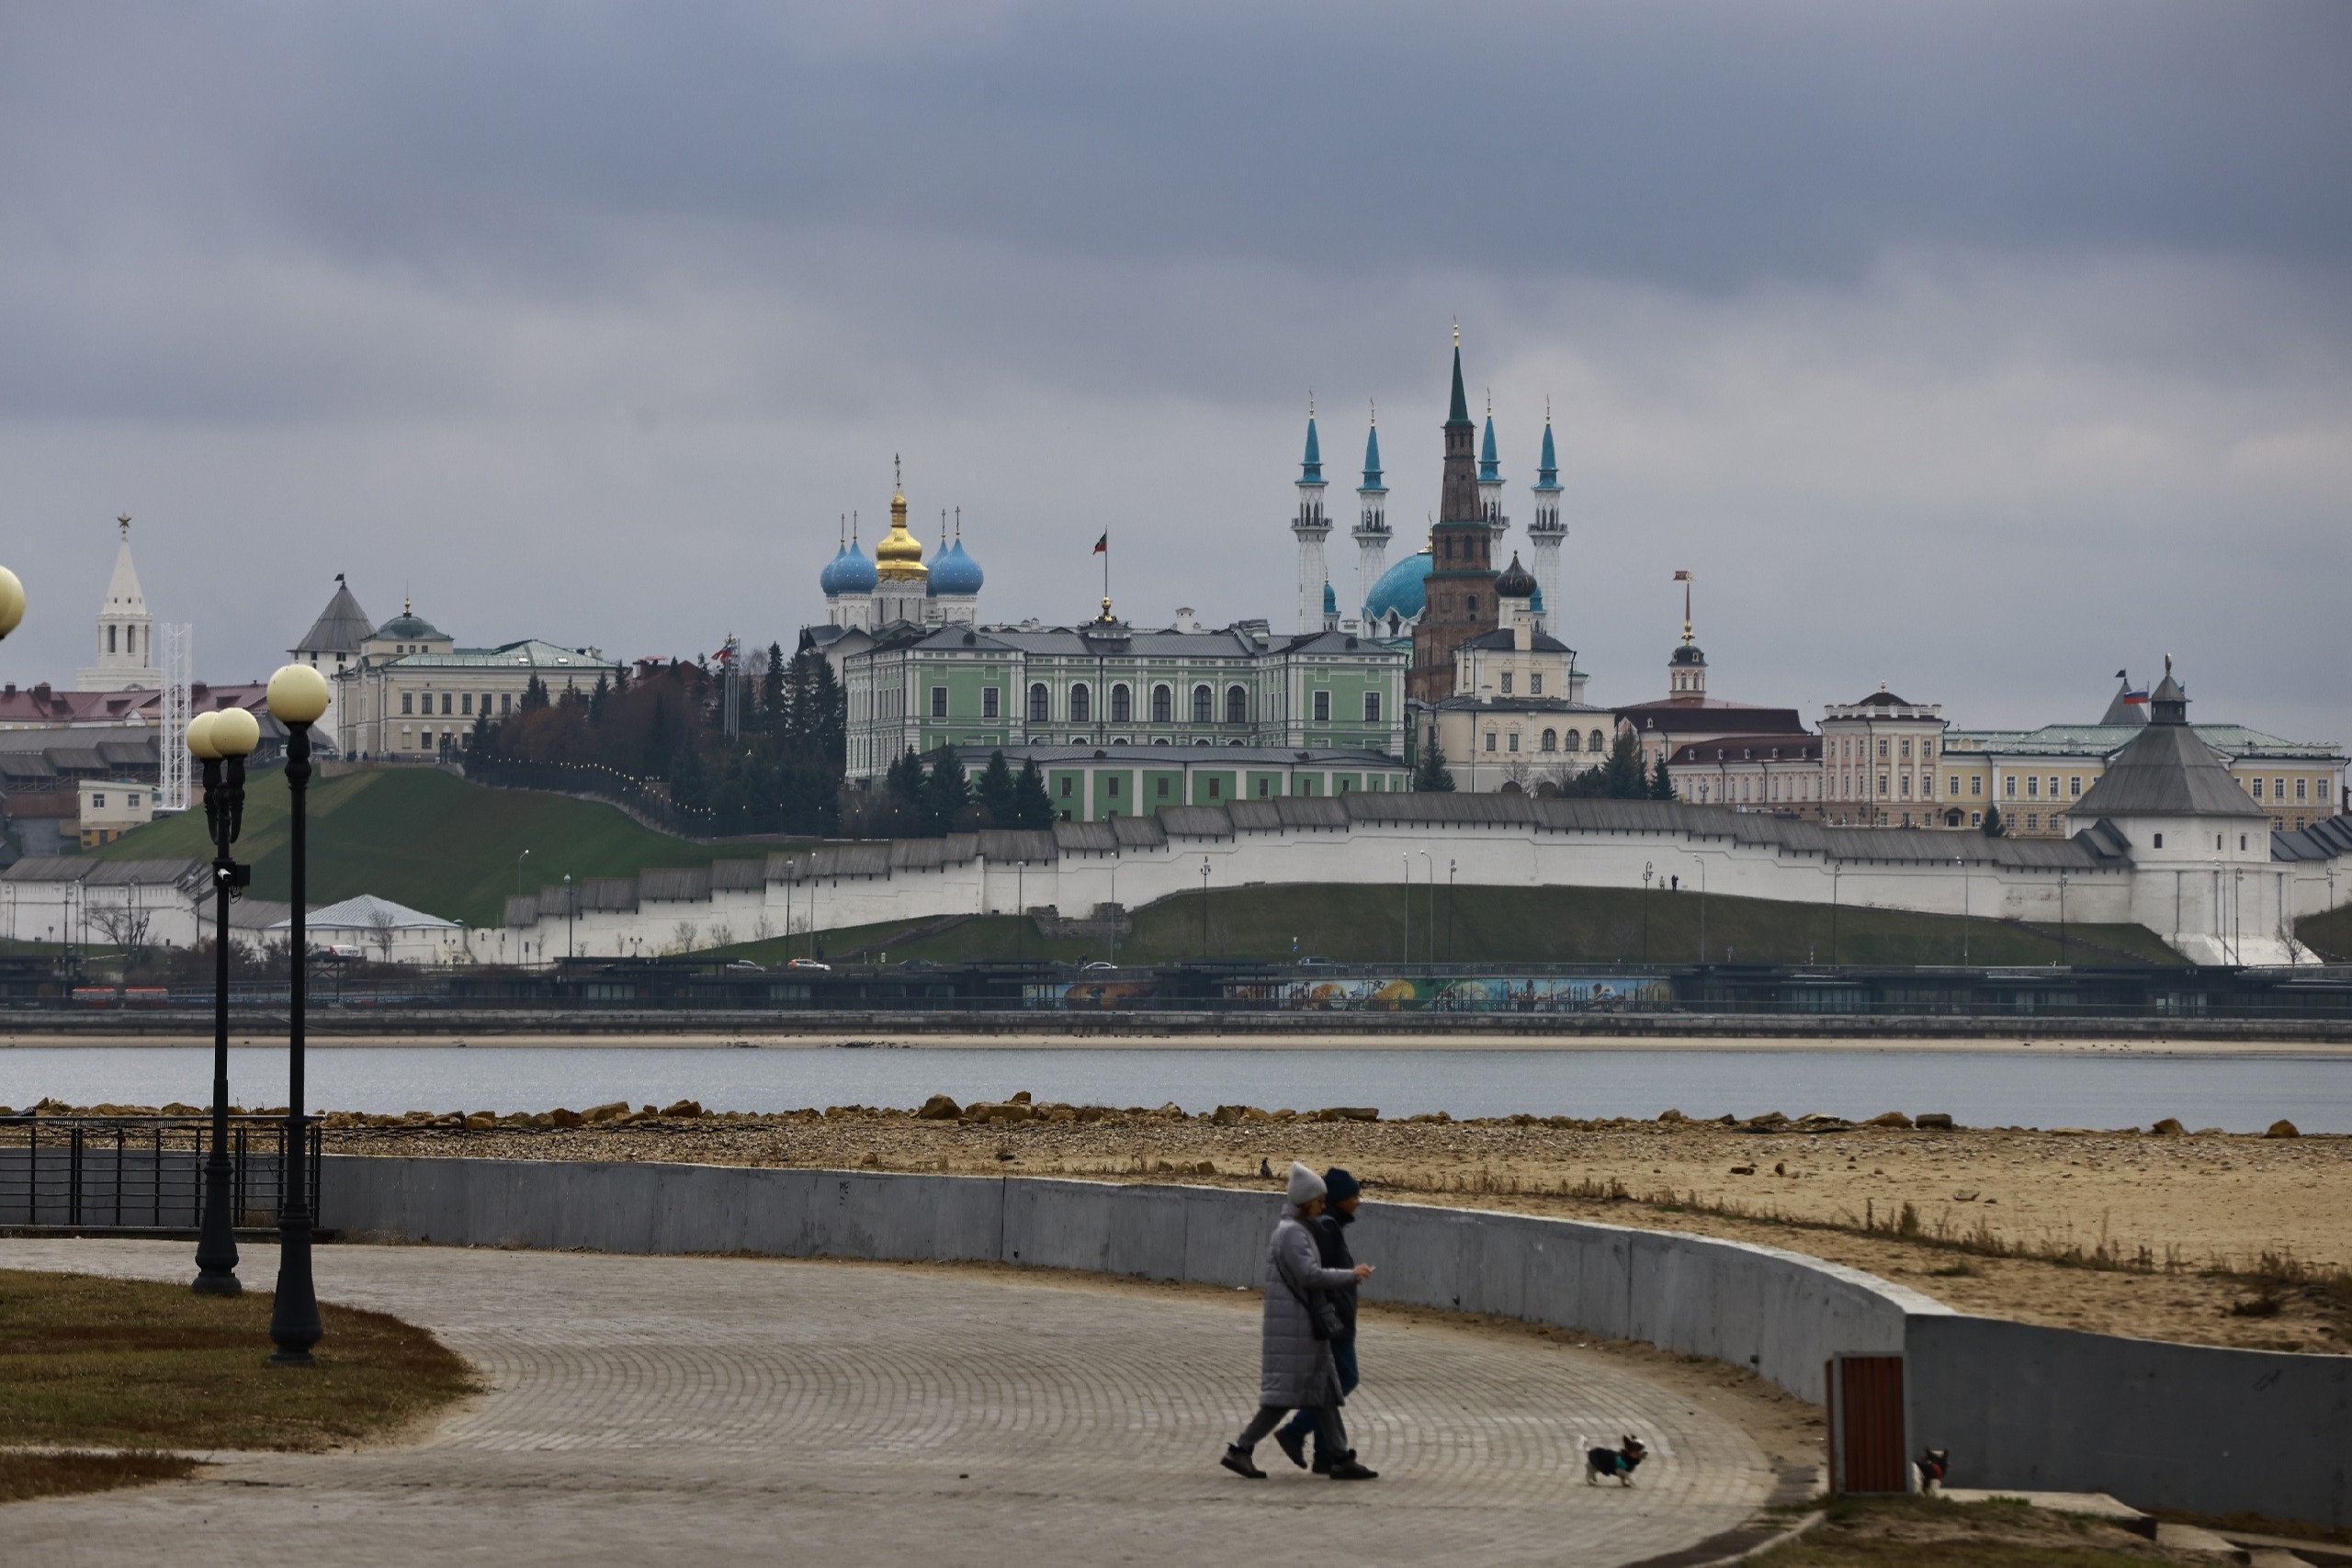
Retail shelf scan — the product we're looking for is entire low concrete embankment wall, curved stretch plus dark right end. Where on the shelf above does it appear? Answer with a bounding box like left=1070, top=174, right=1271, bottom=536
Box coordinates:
left=320, top=1156, right=2352, bottom=1526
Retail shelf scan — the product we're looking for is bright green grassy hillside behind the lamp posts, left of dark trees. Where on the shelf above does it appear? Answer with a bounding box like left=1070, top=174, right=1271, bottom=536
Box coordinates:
left=101, top=769, right=790, bottom=926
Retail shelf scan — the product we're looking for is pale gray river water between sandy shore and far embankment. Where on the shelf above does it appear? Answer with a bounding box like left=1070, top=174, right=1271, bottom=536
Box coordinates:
left=0, top=1046, right=2352, bottom=1134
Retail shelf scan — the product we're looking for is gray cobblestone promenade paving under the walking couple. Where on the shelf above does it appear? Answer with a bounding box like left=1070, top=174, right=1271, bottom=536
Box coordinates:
left=0, top=1241, right=1771, bottom=1568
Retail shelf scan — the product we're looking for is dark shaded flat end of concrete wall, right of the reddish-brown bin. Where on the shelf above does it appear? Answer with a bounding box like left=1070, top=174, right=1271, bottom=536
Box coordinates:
left=1905, top=1316, right=2352, bottom=1526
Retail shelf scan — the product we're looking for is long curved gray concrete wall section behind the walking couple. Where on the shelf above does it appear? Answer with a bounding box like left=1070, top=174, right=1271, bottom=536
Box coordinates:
left=320, top=1155, right=1945, bottom=1401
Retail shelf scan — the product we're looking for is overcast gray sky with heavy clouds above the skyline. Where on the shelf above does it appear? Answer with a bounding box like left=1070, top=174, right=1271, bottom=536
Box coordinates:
left=0, top=0, right=2352, bottom=740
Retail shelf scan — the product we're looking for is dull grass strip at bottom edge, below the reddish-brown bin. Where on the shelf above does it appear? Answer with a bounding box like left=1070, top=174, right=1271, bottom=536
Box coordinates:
left=1757, top=1497, right=2180, bottom=1568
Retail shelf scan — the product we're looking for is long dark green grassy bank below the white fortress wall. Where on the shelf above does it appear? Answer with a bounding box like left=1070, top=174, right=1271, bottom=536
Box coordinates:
left=727, top=884, right=2183, bottom=966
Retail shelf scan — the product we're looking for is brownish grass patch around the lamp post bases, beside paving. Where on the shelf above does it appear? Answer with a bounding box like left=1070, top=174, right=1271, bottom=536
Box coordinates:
left=0, top=1269, right=475, bottom=1491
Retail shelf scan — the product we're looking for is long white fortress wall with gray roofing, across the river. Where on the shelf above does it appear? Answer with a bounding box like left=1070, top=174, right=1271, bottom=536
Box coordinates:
left=468, top=795, right=2352, bottom=964
